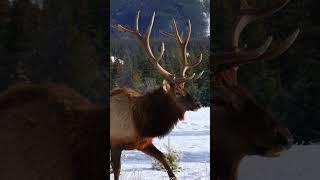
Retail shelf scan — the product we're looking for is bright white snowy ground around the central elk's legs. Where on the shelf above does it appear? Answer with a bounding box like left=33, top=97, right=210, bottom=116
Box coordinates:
left=110, top=108, right=210, bottom=180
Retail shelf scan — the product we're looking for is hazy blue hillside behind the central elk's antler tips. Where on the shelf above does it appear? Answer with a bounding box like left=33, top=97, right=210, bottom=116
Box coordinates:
left=110, top=0, right=210, bottom=37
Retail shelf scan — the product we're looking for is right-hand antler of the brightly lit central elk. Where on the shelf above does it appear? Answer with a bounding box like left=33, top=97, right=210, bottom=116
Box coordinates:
left=160, top=19, right=204, bottom=83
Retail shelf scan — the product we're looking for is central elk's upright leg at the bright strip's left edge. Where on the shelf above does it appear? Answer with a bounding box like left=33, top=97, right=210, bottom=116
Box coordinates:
left=111, top=146, right=122, bottom=180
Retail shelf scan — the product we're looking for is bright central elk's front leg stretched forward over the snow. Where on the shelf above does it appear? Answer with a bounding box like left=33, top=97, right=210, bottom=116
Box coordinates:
left=141, top=144, right=176, bottom=179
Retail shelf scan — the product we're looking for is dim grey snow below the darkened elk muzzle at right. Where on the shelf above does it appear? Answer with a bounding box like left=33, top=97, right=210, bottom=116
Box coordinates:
left=239, top=145, right=320, bottom=180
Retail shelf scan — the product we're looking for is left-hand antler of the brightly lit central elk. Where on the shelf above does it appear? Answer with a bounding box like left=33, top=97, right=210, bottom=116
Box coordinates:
left=112, top=11, right=174, bottom=80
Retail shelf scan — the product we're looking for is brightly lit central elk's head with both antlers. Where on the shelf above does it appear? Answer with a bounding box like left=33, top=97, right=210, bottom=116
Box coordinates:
left=112, top=11, right=203, bottom=111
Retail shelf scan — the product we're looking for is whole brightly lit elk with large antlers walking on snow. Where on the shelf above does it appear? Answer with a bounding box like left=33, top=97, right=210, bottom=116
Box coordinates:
left=110, top=12, right=203, bottom=180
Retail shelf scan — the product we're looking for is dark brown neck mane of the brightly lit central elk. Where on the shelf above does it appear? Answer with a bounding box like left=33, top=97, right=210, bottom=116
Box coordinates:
left=133, top=87, right=185, bottom=137
